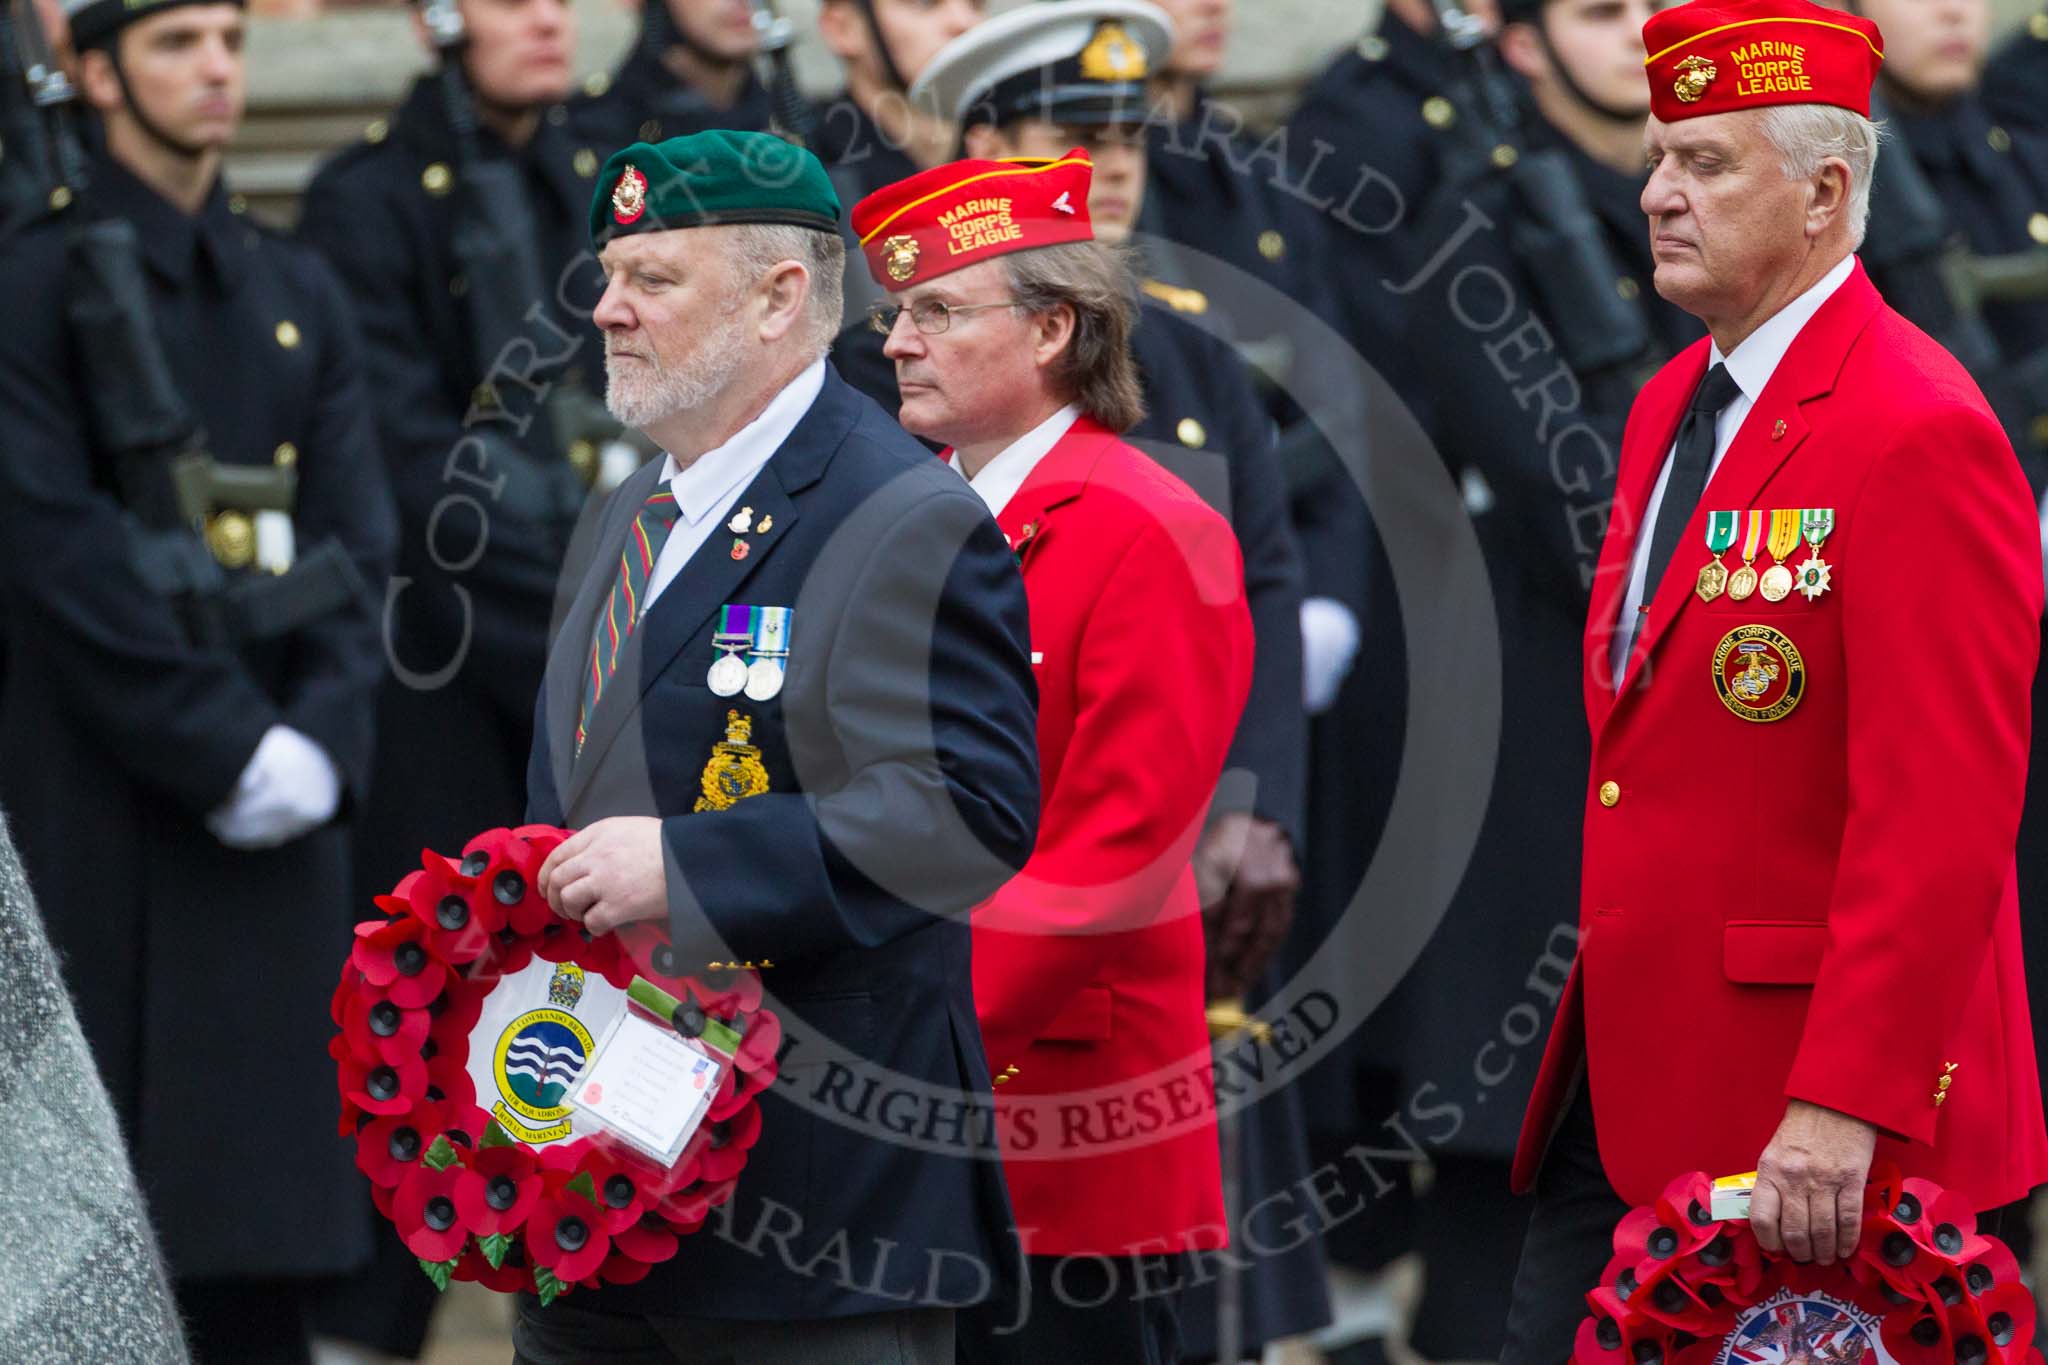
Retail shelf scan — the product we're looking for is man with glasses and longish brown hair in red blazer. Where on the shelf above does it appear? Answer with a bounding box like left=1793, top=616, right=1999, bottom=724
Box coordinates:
left=852, top=151, right=1251, bottom=1365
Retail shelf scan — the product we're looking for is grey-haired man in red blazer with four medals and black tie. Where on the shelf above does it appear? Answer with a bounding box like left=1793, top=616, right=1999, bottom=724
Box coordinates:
left=1503, top=0, right=2048, bottom=1365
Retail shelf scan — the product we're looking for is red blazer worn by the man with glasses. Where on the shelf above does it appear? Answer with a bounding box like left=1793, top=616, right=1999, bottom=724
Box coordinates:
left=975, top=417, right=1251, bottom=1254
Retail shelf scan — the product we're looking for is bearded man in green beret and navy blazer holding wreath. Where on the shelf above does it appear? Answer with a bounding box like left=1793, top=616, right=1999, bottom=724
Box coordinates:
left=514, top=131, right=1038, bottom=1365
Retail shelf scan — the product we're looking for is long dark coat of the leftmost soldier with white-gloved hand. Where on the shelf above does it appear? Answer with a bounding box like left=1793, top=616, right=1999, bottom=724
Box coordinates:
left=0, top=164, right=393, bottom=1277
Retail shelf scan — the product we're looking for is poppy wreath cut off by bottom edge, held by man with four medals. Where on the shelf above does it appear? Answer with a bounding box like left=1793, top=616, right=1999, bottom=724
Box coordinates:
left=1571, top=1164, right=2042, bottom=1365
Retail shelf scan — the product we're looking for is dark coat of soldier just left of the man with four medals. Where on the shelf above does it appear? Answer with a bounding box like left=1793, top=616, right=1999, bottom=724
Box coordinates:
left=1395, top=123, right=1702, bottom=1158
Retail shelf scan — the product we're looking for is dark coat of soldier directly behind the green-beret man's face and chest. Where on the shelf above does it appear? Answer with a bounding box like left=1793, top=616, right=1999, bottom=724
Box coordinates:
left=299, top=76, right=604, bottom=896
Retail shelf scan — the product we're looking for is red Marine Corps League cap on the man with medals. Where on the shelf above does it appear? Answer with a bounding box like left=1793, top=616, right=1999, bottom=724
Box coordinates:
left=1642, top=0, right=1884, bottom=123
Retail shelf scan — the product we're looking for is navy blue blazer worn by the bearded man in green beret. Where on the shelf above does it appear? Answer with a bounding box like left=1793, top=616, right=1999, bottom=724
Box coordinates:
left=528, top=368, right=1038, bottom=1320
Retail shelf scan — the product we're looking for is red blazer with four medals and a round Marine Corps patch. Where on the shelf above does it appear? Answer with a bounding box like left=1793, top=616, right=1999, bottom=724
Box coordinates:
left=1516, top=264, right=2048, bottom=1209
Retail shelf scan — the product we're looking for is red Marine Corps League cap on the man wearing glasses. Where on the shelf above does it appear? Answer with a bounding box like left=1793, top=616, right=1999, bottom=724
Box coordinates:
left=852, top=147, right=1096, bottom=289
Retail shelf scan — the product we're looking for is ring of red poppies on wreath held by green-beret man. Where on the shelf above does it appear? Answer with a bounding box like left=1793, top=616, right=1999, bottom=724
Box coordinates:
left=328, top=825, right=782, bottom=1304
